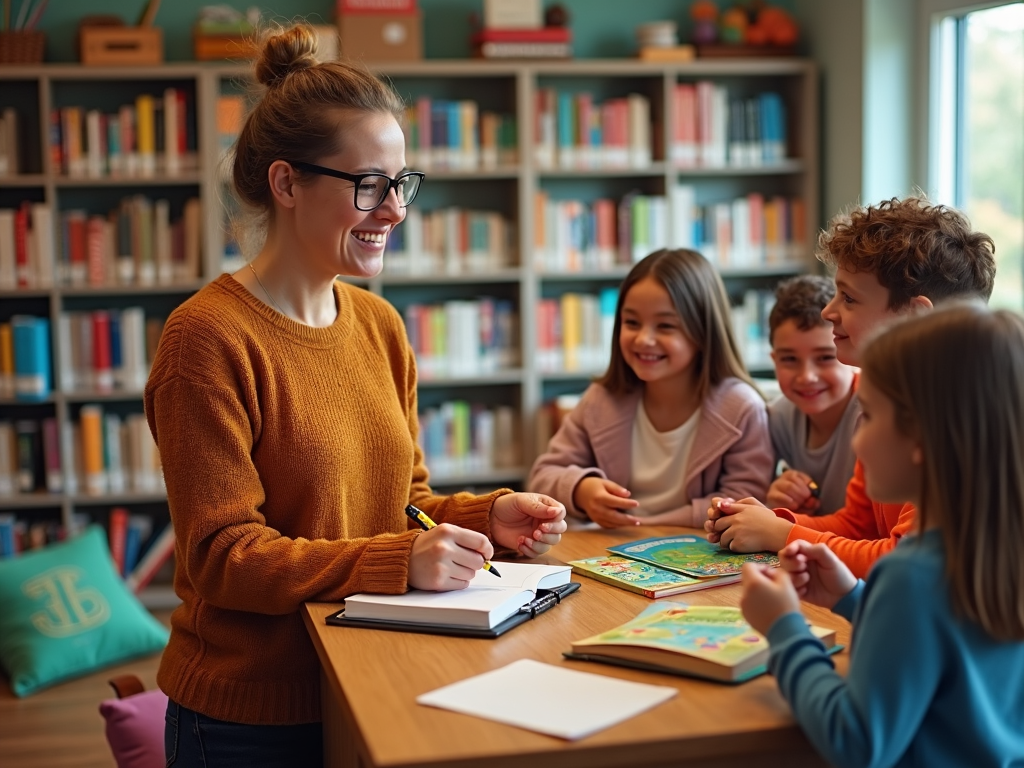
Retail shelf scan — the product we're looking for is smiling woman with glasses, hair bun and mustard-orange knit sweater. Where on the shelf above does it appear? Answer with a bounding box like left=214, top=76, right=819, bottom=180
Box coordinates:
left=145, top=27, right=565, bottom=768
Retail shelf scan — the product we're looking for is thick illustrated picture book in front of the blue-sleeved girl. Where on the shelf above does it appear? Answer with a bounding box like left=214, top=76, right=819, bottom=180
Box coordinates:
left=565, top=600, right=838, bottom=683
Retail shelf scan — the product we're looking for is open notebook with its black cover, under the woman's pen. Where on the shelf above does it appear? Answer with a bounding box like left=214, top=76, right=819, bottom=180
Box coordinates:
left=327, top=562, right=580, bottom=637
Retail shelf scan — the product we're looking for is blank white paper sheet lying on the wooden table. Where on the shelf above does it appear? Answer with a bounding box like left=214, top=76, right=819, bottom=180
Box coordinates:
left=416, top=658, right=678, bottom=740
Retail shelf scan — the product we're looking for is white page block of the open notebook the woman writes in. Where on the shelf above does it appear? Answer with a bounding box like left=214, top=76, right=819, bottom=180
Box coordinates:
left=344, top=562, right=572, bottom=630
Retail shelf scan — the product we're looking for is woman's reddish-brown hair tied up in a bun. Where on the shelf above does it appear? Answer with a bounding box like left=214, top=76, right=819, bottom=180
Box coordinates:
left=231, top=25, right=404, bottom=244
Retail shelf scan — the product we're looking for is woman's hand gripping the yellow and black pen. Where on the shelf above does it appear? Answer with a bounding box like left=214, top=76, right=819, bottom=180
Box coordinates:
left=409, top=523, right=495, bottom=592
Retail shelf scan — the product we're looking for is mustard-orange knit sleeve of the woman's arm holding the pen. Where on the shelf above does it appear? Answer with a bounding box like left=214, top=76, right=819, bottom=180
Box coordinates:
left=145, top=376, right=416, bottom=614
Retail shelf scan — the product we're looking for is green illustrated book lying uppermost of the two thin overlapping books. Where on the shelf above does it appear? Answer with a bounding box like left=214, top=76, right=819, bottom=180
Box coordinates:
left=608, top=536, right=778, bottom=579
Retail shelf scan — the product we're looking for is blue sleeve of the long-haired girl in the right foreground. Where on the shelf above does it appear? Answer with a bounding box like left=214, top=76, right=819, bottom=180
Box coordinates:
left=768, top=561, right=944, bottom=768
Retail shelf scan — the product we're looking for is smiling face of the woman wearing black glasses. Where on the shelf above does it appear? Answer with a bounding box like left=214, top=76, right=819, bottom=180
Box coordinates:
left=295, top=113, right=406, bottom=278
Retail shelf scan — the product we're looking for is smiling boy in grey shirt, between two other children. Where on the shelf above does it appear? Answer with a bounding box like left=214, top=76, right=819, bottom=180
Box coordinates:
left=767, top=274, right=860, bottom=515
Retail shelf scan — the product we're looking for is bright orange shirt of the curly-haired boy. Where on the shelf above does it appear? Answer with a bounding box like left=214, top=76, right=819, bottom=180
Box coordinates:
left=776, top=460, right=915, bottom=579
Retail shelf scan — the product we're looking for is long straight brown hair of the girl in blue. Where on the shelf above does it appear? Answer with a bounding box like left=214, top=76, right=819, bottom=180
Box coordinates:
left=863, top=302, right=1024, bottom=641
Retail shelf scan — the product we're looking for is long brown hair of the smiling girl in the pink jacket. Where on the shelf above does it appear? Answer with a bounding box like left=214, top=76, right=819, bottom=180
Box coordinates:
left=597, top=248, right=756, bottom=400
